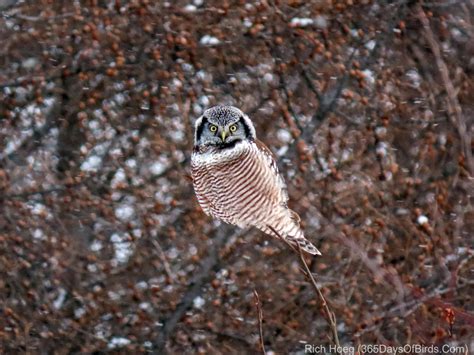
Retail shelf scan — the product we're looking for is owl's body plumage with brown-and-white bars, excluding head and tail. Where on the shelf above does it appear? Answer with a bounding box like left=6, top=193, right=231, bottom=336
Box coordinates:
left=191, top=141, right=288, bottom=229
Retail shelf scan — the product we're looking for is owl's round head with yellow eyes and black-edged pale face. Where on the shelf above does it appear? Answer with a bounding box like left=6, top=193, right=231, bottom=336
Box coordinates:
left=194, top=106, right=256, bottom=148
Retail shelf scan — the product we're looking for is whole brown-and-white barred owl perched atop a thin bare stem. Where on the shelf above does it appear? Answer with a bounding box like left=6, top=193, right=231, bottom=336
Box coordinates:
left=191, top=106, right=321, bottom=255
